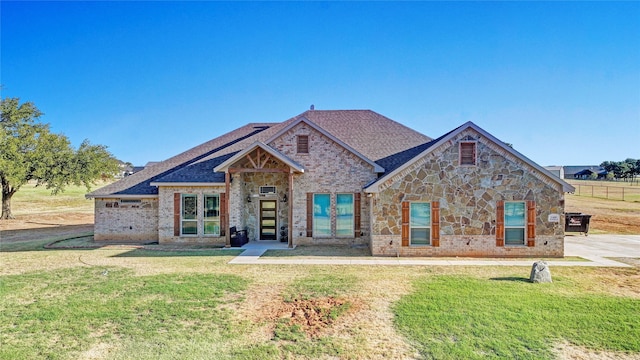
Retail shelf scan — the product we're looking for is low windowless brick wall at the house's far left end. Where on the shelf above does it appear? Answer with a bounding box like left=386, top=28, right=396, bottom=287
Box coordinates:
left=93, top=198, right=158, bottom=241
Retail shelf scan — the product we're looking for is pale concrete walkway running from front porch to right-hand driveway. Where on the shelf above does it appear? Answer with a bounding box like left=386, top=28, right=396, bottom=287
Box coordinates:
left=229, top=235, right=640, bottom=267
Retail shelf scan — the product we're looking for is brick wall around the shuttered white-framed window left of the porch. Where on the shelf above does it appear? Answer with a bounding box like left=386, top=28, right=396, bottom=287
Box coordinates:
left=157, top=186, right=226, bottom=245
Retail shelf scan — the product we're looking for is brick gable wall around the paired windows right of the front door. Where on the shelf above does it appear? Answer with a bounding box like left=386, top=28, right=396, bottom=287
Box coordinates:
left=269, top=122, right=377, bottom=245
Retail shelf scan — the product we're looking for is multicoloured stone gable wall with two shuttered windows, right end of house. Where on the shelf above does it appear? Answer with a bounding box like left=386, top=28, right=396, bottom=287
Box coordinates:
left=371, top=129, right=564, bottom=257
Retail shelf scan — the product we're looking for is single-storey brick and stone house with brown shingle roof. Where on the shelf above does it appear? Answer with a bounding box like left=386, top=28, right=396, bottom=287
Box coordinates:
left=87, top=110, right=574, bottom=256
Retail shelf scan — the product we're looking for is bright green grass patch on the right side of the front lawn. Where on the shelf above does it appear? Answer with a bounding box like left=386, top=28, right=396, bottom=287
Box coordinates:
left=394, top=276, right=640, bottom=359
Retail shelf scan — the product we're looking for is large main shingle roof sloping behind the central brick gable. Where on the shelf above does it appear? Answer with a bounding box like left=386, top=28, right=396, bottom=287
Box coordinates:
left=87, top=110, right=431, bottom=197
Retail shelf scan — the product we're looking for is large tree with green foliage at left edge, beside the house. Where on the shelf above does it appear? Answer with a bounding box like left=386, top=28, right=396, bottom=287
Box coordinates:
left=0, top=98, right=118, bottom=219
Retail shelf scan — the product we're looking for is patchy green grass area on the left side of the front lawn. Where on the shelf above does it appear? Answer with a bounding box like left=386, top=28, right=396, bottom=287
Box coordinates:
left=0, top=267, right=247, bottom=359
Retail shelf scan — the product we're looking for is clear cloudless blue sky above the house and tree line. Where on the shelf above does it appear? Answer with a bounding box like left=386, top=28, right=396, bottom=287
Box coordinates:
left=0, top=1, right=640, bottom=165
